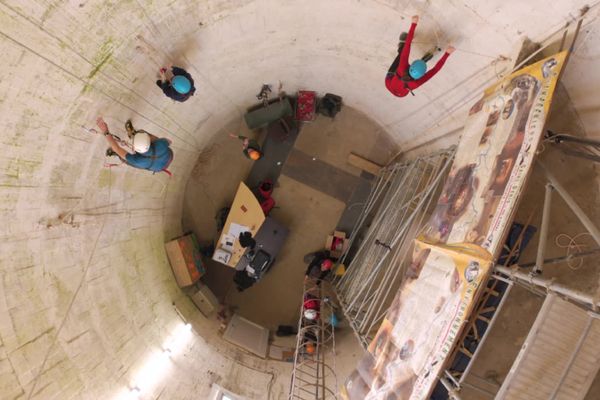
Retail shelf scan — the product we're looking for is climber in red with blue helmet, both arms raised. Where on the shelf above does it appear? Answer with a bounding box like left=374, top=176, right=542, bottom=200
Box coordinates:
left=385, top=15, right=454, bottom=97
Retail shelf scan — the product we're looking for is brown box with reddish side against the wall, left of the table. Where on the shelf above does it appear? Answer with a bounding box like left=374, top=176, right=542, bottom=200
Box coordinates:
left=165, top=234, right=205, bottom=287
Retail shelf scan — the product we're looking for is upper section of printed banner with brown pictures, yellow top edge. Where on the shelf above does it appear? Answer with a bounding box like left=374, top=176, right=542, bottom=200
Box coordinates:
left=423, top=51, right=567, bottom=256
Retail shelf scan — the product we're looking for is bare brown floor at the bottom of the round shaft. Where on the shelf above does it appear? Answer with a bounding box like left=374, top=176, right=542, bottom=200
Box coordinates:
left=182, top=107, right=396, bottom=330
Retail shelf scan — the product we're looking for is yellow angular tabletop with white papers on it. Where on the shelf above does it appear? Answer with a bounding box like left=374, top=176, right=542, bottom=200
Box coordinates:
left=213, top=182, right=265, bottom=268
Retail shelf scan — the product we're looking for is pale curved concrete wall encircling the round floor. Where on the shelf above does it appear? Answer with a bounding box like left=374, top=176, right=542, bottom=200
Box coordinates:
left=0, top=0, right=597, bottom=399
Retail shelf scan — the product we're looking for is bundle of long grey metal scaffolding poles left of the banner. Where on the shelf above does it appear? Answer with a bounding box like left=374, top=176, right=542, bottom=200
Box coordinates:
left=334, top=147, right=455, bottom=349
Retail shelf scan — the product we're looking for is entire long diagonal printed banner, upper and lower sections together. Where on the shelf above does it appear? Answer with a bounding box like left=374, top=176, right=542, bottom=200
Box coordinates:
left=341, top=52, right=567, bottom=400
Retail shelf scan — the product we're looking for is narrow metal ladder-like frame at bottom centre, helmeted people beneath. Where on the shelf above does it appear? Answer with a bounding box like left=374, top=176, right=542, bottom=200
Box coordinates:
left=288, top=278, right=338, bottom=400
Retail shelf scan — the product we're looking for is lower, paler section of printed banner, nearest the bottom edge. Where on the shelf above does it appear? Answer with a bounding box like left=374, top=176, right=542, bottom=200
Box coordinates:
left=343, top=241, right=492, bottom=400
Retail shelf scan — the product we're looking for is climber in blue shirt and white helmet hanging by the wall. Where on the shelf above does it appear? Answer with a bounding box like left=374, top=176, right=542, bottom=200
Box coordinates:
left=96, top=117, right=173, bottom=175
